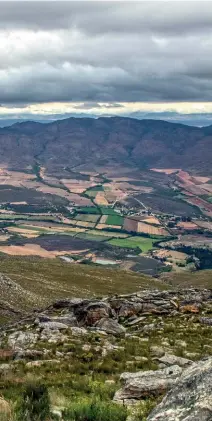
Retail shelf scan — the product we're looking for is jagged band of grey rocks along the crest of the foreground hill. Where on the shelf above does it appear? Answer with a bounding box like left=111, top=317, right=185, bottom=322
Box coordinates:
left=0, top=288, right=212, bottom=332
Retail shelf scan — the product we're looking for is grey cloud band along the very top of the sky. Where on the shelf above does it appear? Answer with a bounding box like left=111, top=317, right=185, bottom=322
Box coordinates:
left=0, top=1, right=212, bottom=34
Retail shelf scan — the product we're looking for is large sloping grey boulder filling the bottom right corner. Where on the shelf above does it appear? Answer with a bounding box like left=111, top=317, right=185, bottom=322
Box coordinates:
left=147, top=357, right=212, bottom=421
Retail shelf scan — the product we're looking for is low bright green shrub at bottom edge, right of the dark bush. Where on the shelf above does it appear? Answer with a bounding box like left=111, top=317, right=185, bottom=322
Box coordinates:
left=63, top=400, right=127, bottom=421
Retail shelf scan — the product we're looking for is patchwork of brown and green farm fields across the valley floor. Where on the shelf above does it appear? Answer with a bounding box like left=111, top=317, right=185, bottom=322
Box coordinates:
left=0, top=165, right=211, bottom=274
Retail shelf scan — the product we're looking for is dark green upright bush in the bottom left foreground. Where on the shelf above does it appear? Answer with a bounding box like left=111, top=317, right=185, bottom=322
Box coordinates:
left=16, top=384, right=50, bottom=421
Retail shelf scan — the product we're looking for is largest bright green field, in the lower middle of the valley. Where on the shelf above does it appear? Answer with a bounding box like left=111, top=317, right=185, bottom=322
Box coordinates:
left=108, top=236, right=155, bottom=252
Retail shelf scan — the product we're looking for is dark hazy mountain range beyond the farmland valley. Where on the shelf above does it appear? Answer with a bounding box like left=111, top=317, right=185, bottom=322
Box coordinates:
left=0, top=117, right=212, bottom=173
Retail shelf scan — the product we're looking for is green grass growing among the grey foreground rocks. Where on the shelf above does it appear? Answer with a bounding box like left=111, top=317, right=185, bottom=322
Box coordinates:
left=0, top=296, right=212, bottom=421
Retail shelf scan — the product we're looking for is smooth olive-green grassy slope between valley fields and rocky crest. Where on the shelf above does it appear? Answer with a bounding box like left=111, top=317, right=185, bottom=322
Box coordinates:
left=0, top=254, right=167, bottom=314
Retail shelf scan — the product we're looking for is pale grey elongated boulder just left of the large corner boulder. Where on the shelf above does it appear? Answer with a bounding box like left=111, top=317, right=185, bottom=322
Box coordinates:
left=114, top=365, right=182, bottom=402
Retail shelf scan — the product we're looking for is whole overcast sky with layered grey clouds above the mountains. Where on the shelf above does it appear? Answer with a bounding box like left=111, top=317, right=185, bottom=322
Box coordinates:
left=0, top=0, right=212, bottom=121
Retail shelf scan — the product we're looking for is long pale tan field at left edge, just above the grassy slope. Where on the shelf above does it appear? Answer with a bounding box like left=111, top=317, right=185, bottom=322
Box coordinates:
left=0, top=244, right=87, bottom=259
